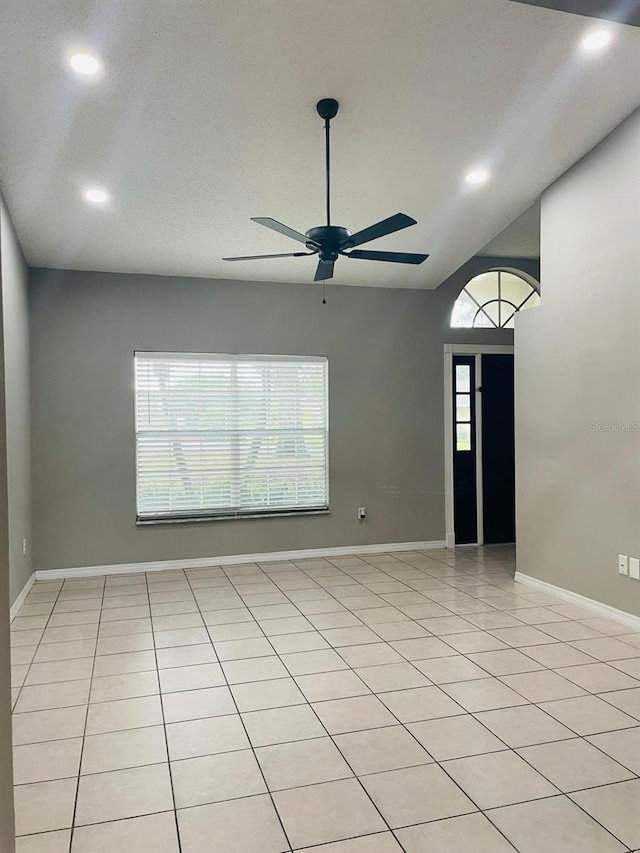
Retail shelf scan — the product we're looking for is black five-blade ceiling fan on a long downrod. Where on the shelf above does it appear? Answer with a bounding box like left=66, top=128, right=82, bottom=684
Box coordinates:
left=222, top=98, right=429, bottom=281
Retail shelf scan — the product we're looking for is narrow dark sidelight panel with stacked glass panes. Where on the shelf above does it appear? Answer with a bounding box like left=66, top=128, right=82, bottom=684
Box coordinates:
left=452, top=355, right=478, bottom=545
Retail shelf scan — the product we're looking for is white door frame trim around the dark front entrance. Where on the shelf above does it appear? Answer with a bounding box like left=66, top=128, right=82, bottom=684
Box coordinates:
left=444, top=344, right=514, bottom=548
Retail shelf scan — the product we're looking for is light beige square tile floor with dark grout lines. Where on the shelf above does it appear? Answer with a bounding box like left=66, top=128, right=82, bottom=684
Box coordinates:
left=12, top=546, right=640, bottom=853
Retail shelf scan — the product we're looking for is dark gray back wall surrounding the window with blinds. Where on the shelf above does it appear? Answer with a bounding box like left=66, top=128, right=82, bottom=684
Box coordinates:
left=31, top=258, right=537, bottom=569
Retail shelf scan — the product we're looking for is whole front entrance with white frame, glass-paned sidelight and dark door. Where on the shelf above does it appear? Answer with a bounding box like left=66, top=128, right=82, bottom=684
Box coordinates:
left=444, top=344, right=515, bottom=547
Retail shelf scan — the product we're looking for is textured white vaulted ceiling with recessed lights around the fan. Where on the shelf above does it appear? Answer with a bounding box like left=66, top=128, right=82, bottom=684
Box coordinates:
left=0, top=0, right=640, bottom=287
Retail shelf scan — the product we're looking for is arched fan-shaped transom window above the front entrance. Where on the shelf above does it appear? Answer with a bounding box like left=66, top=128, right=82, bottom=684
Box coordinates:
left=451, top=270, right=540, bottom=329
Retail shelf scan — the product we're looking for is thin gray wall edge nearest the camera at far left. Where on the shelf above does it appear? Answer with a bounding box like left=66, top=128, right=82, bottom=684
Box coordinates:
left=0, top=195, right=15, bottom=853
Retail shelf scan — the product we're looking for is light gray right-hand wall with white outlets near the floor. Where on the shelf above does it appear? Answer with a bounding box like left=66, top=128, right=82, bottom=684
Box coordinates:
left=515, top=111, right=640, bottom=615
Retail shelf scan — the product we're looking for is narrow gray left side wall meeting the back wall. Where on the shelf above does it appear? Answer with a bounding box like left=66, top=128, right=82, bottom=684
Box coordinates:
left=0, top=196, right=32, bottom=602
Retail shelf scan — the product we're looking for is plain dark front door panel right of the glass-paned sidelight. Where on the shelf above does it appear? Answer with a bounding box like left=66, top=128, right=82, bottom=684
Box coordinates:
left=482, top=355, right=516, bottom=544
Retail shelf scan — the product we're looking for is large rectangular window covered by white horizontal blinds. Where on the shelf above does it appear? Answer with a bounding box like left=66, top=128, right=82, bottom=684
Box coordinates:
left=135, top=353, right=328, bottom=522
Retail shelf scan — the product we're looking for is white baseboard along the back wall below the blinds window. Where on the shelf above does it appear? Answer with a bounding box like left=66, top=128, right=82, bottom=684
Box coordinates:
left=35, top=539, right=446, bottom=581
